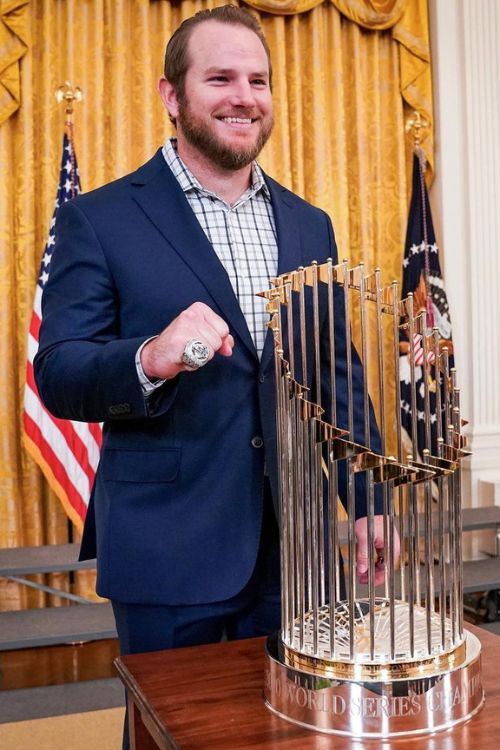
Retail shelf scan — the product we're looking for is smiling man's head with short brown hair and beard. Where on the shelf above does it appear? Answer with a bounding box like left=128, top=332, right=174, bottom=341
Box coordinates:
left=159, top=13, right=273, bottom=185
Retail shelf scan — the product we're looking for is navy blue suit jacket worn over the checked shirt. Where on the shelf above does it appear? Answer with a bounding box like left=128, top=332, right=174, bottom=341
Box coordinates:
left=35, top=151, right=378, bottom=604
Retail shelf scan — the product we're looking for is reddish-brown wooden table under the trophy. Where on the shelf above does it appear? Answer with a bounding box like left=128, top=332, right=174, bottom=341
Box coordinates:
left=115, top=625, right=500, bottom=750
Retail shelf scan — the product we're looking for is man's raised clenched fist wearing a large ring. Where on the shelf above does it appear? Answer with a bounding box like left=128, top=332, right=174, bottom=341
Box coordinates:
left=141, top=302, right=234, bottom=380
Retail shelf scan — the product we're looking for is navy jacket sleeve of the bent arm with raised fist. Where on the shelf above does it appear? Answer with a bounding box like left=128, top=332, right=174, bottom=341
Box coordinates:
left=34, top=201, right=177, bottom=422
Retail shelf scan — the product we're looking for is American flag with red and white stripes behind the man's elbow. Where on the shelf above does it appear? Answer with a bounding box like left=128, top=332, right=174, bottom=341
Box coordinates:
left=23, top=131, right=102, bottom=529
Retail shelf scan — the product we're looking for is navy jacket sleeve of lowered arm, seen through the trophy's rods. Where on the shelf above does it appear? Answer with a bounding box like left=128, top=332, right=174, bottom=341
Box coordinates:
left=322, top=216, right=383, bottom=518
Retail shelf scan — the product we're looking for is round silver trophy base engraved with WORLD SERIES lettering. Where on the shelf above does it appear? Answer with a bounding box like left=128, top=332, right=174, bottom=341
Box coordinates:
left=264, top=631, right=484, bottom=739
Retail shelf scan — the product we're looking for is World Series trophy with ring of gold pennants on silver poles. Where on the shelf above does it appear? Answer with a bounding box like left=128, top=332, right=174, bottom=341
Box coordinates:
left=263, top=260, right=484, bottom=738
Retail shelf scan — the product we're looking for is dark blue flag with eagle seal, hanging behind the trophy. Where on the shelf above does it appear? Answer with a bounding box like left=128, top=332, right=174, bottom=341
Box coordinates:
left=399, top=153, right=453, bottom=459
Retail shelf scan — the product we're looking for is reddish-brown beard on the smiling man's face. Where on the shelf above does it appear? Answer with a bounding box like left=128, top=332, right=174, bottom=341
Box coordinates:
left=176, top=102, right=274, bottom=172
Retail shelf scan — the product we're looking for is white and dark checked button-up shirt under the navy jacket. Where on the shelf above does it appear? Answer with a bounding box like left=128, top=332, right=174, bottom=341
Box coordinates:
left=163, top=138, right=278, bottom=356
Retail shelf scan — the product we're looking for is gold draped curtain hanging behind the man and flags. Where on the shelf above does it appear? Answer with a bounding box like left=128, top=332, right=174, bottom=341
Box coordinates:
left=0, top=0, right=432, bottom=609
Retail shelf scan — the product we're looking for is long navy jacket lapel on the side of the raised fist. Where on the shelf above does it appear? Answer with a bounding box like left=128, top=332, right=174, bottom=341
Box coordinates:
left=132, top=151, right=256, bottom=357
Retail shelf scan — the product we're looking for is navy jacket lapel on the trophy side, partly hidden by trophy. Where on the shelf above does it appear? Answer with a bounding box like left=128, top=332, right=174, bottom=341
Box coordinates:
left=261, top=176, right=302, bottom=370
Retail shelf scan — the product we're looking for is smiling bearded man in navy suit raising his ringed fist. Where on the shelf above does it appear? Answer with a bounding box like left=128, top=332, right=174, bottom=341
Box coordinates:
left=35, top=6, right=394, bottom=664
